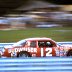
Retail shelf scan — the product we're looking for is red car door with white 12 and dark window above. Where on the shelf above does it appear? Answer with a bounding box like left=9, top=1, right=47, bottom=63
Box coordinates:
left=37, top=40, right=56, bottom=57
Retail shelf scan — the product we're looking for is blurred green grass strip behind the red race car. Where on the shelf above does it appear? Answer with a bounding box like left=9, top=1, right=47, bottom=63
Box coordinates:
left=0, top=27, right=72, bottom=43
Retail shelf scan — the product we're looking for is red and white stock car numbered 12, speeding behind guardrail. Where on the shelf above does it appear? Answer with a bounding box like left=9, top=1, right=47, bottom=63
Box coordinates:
left=0, top=37, right=72, bottom=57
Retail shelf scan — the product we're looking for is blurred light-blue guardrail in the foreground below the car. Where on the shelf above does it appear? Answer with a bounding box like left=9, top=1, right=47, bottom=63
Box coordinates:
left=0, top=57, right=72, bottom=72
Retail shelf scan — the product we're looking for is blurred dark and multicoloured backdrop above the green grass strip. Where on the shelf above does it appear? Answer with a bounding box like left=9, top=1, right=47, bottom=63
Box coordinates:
left=0, top=0, right=72, bottom=29
